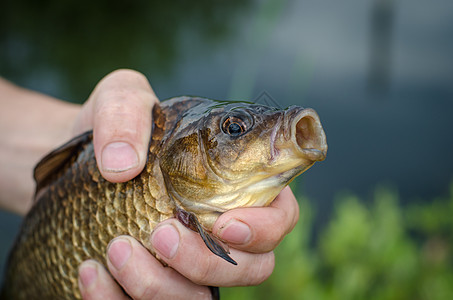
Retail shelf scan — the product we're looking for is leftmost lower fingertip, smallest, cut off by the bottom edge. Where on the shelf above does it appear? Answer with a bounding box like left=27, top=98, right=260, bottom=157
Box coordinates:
left=79, top=260, right=129, bottom=300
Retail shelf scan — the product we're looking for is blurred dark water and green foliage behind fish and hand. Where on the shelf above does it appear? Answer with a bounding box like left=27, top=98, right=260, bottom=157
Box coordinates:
left=0, top=0, right=453, bottom=299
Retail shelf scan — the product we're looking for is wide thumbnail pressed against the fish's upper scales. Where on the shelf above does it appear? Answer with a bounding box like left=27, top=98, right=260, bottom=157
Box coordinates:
left=101, top=142, right=138, bottom=173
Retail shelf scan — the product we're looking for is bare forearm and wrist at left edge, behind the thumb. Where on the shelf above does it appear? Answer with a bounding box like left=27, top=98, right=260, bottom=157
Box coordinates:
left=0, top=78, right=80, bottom=214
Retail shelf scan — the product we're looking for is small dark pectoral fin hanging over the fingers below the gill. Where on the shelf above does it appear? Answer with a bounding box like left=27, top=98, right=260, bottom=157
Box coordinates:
left=176, top=208, right=237, bottom=265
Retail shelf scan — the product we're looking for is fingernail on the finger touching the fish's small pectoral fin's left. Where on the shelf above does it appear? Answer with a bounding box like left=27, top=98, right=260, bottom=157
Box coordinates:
left=151, top=225, right=179, bottom=259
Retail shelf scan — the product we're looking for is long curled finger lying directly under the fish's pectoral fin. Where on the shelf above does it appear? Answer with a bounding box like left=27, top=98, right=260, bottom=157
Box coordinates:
left=151, top=219, right=275, bottom=286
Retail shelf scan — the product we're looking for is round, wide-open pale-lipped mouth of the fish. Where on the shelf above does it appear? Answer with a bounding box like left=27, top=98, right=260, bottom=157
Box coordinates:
left=291, top=108, right=327, bottom=162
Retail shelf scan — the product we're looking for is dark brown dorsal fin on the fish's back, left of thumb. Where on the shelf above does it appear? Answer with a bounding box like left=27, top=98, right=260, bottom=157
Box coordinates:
left=33, top=130, right=93, bottom=200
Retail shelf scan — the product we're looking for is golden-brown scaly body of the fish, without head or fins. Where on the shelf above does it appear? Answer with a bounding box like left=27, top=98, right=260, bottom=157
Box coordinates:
left=3, top=136, right=172, bottom=299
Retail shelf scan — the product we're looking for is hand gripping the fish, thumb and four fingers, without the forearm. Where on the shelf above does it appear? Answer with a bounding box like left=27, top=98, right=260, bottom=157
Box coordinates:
left=76, top=70, right=299, bottom=299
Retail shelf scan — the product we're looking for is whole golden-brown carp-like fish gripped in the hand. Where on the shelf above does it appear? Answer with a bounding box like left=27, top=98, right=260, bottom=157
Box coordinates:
left=2, top=96, right=327, bottom=299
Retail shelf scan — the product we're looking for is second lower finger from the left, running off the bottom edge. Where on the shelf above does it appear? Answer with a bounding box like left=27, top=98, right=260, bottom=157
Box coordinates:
left=104, top=236, right=211, bottom=299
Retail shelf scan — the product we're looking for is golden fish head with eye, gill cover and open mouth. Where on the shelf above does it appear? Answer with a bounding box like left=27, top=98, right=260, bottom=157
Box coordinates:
left=161, top=100, right=327, bottom=227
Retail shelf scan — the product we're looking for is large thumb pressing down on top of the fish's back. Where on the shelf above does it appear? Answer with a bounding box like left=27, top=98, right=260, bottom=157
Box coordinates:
left=76, top=70, right=158, bottom=182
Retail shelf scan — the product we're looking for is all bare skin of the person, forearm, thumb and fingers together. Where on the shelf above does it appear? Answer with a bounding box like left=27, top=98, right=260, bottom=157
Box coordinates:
left=0, top=70, right=299, bottom=299
